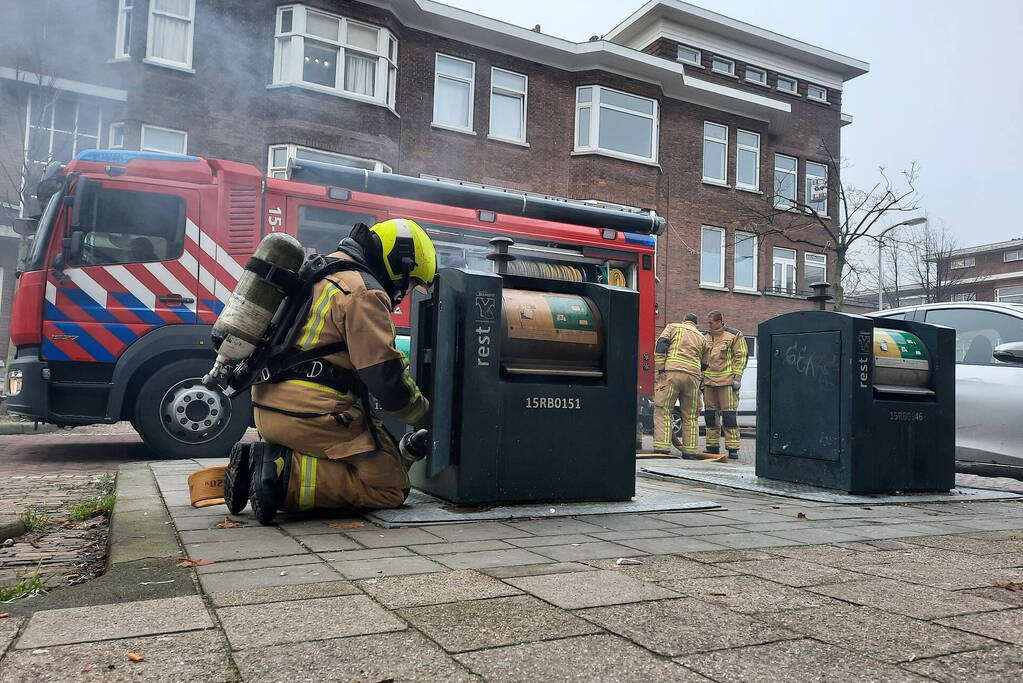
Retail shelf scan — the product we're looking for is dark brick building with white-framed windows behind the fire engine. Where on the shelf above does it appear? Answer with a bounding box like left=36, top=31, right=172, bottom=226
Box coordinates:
left=0, top=0, right=868, bottom=359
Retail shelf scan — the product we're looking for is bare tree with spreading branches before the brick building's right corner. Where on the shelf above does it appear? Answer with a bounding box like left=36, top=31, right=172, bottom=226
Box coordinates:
left=737, top=142, right=920, bottom=311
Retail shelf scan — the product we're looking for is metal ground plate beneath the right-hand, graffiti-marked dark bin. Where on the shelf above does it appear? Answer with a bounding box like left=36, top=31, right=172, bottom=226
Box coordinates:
left=637, top=462, right=1023, bottom=505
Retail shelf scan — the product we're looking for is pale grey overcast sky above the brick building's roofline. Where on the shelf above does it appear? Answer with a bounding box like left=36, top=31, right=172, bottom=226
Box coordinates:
left=443, top=0, right=1023, bottom=245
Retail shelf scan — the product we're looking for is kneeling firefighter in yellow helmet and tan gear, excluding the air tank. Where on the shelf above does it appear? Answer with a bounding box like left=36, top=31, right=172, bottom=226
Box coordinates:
left=225, top=219, right=437, bottom=523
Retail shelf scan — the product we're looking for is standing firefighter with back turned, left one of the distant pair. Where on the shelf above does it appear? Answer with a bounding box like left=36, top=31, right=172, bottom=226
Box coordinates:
left=654, top=313, right=707, bottom=458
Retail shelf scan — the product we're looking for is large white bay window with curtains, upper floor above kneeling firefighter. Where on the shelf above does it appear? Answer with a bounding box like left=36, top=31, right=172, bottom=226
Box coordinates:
left=273, top=5, right=398, bottom=109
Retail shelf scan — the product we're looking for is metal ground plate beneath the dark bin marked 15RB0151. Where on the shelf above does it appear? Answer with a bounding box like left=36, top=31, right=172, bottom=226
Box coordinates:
left=365, top=483, right=721, bottom=527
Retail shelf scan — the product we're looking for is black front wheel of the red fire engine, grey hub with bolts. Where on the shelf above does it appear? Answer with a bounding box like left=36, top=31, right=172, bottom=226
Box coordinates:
left=132, top=358, right=252, bottom=458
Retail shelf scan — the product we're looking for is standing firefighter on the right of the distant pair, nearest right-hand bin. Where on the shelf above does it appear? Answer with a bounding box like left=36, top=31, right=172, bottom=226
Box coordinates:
left=703, top=311, right=748, bottom=459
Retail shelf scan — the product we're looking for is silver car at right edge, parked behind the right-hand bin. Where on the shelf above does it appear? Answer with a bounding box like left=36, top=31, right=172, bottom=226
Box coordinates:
left=867, top=302, right=1023, bottom=479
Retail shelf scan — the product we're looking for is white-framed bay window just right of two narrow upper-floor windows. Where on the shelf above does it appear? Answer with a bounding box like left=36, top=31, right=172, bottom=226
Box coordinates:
left=575, top=86, right=658, bottom=162
